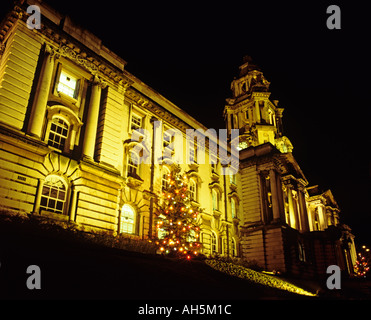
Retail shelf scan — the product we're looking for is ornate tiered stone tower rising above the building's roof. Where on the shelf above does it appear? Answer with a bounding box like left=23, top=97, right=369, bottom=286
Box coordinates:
left=224, top=56, right=293, bottom=153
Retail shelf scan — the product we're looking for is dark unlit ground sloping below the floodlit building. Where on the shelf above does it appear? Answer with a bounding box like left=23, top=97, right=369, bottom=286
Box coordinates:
left=0, top=215, right=370, bottom=301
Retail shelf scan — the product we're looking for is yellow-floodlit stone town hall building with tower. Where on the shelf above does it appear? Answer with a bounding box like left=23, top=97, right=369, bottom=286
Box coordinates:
left=0, top=1, right=356, bottom=276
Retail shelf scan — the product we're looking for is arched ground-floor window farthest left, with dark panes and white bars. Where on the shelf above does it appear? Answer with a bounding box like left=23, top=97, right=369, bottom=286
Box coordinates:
left=40, top=176, right=67, bottom=214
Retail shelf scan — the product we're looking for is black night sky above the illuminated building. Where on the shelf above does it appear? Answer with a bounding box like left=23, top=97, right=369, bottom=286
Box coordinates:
left=0, top=0, right=371, bottom=245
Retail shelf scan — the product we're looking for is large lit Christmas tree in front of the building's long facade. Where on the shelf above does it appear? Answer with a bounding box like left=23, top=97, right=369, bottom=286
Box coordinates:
left=155, top=166, right=201, bottom=260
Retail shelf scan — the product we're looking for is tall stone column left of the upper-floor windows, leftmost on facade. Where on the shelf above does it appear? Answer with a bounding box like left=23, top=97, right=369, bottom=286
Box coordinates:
left=28, top=45, right=55, bottom=138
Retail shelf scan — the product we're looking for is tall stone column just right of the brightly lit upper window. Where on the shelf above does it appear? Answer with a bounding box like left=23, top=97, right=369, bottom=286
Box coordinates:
left=82, top=77, right=102, bottom=159
